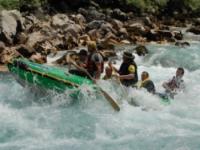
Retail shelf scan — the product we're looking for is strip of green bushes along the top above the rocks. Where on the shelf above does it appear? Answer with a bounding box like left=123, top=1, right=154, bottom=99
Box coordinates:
left=0, top=0, right=200, bottom=15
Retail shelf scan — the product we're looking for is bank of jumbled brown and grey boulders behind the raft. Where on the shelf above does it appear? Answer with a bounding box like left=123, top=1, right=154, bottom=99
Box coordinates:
left=0, top=5, right=200, bottom=72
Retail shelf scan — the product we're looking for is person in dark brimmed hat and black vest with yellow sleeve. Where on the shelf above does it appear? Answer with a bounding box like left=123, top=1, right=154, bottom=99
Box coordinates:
left=113, top=52, right=138, bottom=87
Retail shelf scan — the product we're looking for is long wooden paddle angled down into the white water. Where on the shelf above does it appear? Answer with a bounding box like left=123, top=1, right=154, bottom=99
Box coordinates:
left=68, top=58, right=120, bottom=111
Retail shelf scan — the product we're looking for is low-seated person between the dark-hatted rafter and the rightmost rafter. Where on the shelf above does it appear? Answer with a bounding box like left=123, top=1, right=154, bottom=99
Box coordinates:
left=137, top=71, right=156, bottom=94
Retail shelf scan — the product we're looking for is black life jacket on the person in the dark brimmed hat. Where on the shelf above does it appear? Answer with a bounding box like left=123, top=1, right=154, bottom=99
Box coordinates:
left=119, top=61, right=138, bottom=86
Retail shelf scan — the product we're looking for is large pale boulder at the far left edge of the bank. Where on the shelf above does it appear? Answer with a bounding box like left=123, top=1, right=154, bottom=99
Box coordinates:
left=0, top=10, right=23, bottom=45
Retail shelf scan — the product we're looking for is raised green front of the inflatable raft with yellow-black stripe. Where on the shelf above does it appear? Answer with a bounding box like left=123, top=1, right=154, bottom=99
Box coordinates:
left=8, top=58, right=93, bottom=92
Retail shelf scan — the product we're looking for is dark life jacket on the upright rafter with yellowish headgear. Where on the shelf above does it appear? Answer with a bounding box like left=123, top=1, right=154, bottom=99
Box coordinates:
left=87, top=52, right=104, bottom=77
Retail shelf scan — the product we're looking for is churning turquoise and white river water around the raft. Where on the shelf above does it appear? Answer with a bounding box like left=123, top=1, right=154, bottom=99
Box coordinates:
left=0, top=42, right=200, bottom=150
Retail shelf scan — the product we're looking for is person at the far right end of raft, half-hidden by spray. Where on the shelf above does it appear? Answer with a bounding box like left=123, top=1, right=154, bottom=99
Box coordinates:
left=162, top=67, right=185, bottom=98
